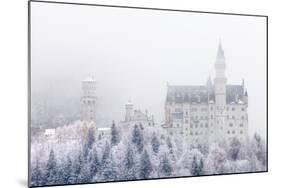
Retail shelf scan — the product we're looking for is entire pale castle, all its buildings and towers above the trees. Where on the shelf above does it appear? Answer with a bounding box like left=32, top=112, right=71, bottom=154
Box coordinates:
left=43, top=43, right=248, bottom=146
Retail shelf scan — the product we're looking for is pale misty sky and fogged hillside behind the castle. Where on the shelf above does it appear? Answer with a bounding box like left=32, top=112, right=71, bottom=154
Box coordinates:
left=31, top=2, right=266, bottom=136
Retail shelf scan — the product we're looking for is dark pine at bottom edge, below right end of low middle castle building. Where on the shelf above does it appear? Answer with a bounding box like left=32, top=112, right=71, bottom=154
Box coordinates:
left=139, top=150, right=152, bottom=179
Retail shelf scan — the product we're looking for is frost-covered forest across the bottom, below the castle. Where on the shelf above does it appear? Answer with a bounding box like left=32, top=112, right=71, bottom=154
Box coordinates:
left=30, top=122, right=267, bottom=186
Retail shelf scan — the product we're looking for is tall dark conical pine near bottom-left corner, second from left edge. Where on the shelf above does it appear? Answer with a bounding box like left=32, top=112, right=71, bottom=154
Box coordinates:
left=44, top=149, right=58, bottom=185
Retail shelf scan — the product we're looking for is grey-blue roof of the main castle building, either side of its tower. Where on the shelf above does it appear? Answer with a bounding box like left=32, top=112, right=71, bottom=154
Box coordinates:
left=166, top=85, right=244, bottom=104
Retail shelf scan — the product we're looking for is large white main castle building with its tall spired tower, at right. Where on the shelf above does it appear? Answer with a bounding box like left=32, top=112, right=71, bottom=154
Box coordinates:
left=163, top=44, right=248, bottom=145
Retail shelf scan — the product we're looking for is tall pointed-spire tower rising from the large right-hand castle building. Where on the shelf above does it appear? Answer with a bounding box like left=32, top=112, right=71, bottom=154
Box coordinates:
left=214, top=43, right=227, bottom=138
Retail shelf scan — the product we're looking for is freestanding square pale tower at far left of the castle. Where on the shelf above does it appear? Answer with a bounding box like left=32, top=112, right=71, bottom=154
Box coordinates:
left=81, top=77, right=96, bottom=122
